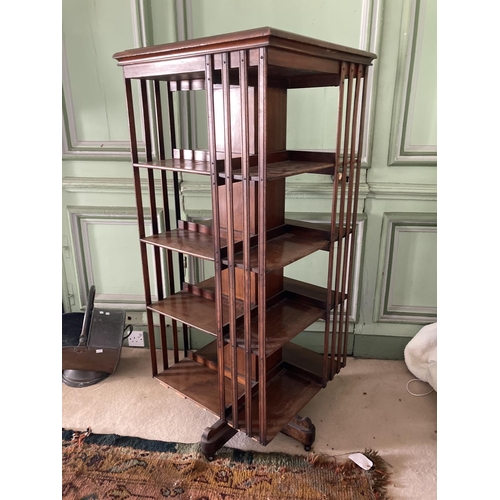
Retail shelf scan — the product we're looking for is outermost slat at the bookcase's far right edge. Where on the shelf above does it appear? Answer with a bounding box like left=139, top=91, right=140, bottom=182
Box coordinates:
left=343, top=65, right=368, bottom=365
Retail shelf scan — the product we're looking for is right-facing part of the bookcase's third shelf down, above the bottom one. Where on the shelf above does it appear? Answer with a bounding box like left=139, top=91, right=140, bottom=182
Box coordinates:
left=236, top=298, right=325, bottom=357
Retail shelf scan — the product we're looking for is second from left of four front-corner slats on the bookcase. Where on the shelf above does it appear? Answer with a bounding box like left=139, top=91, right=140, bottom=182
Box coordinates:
left=222, top=52, right=238, bottom=429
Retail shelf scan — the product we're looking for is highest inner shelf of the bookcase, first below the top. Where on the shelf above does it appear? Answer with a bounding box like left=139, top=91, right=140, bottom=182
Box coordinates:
left=134, top=150, right=335, bottom=181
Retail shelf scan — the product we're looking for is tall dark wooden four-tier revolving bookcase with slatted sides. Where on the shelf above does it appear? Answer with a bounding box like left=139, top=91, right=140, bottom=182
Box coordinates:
left=113, top=27, right=376, bottom=458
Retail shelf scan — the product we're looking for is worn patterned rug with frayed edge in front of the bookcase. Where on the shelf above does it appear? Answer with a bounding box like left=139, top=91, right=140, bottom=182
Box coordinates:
left=62, top=429, right=389, bottom=500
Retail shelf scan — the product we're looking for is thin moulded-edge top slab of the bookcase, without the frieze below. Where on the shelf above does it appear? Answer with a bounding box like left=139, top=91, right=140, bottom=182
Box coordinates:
left=113, top=27, right=377, bottom=66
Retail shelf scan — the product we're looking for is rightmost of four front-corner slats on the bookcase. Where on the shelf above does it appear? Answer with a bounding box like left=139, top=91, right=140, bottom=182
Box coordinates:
left=257, top=47, right=267, bottom=444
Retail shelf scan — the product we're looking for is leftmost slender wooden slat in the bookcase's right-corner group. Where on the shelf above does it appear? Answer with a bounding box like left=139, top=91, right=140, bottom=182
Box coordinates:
left=323, top=63, right=346, bottom=385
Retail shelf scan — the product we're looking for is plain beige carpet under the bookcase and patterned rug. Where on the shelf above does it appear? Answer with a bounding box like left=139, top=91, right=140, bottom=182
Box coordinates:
left=62, top=347, right=437, bottom=500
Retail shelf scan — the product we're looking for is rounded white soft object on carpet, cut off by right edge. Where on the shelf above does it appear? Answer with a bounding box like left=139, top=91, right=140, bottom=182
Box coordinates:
left=404, top=323, right=437, bottom=392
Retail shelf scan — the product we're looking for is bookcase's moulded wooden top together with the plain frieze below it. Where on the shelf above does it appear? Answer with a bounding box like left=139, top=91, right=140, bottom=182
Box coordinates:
left=113, top=27, right=377, bottom=88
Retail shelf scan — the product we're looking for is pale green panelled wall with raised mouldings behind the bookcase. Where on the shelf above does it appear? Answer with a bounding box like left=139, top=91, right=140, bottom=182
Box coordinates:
left=62, top=0, right=437, bottom=359
